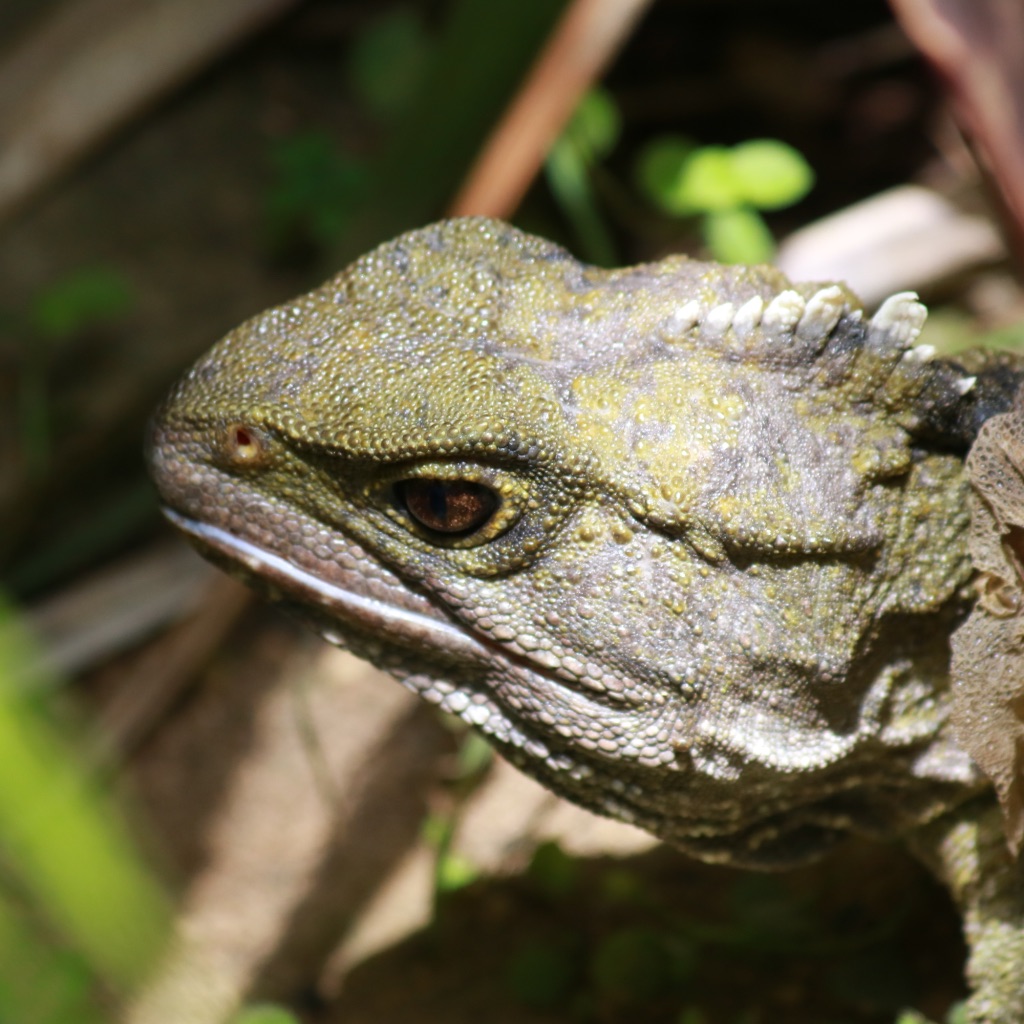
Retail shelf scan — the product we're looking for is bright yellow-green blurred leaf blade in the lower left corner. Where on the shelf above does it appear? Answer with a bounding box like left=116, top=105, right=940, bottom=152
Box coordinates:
left=0, top=605, right=170, bottom=1024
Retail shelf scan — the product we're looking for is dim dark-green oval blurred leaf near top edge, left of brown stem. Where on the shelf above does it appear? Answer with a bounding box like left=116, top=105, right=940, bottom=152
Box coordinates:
left=348, top=7, right=432, bottom=120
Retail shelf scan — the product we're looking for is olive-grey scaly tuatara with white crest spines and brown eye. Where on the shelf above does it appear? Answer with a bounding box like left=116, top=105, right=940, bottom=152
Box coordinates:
left=147, top=218, right=1024, bottom=1024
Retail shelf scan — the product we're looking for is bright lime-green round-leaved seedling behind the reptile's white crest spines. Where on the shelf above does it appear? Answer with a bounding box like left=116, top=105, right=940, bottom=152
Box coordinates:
left=636, top=135, right=814, bottom=263
